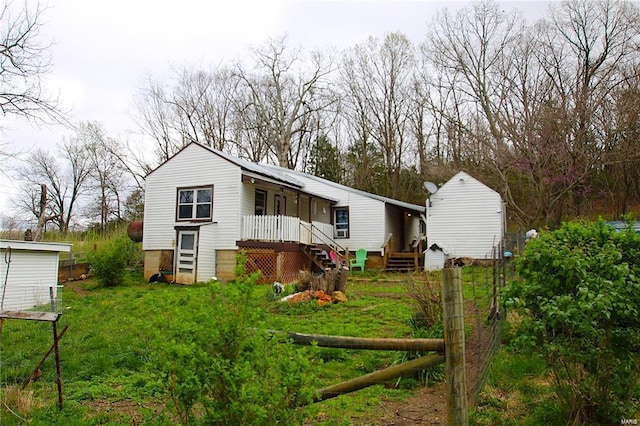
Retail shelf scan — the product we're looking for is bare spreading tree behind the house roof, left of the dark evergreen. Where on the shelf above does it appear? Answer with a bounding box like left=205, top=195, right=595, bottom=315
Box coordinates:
left=236, top=37, right=335, bottom=168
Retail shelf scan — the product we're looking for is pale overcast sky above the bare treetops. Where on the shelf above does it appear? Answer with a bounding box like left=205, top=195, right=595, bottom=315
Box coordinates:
left=0, top=0, right=546, bottom=223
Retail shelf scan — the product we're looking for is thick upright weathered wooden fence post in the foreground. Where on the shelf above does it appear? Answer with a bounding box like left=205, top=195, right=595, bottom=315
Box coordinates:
left=442, top=267, right=469, bottom=426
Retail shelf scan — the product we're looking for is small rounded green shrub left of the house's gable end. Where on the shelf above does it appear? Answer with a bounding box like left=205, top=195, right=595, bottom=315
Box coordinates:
left=87, top=236, right=140, bottom=287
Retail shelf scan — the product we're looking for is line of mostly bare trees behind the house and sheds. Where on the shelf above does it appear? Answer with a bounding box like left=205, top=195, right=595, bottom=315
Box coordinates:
left=8, top=0, right=640, bottom=233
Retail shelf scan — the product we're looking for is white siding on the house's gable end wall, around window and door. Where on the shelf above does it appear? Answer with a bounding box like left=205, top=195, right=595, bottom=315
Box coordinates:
left=142, top=144, right=242, bottom=250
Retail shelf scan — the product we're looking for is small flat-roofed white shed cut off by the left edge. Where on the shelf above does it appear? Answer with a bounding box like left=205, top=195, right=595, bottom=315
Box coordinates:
left=0, top=240, right=71, bottom=311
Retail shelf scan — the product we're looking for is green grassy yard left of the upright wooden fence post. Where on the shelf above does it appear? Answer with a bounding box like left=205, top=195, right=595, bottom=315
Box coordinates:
left=0, top=272, right=430, bottom=425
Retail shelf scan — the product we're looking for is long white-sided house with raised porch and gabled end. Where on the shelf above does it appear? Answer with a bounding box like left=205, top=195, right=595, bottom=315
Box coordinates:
left=143, top=143, right=425, bottom=284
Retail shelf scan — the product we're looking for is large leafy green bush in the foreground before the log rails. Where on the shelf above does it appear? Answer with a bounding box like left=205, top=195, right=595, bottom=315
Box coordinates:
left=158, top=254, right=314, bottom=425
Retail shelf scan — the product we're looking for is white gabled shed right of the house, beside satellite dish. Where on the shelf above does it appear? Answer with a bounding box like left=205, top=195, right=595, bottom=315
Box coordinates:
left=426, top=172, right=505, bottom=259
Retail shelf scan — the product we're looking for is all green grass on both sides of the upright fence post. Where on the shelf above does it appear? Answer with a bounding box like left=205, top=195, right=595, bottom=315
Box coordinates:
left=0, top=268, right=608, bottom=425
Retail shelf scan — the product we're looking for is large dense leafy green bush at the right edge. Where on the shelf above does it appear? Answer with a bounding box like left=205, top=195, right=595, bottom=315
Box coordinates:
left=506, top=221, right=640, bottom=424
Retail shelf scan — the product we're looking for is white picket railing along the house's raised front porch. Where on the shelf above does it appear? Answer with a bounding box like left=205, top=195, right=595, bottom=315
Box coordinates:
left=240, top=215, right=333, bottom=244
